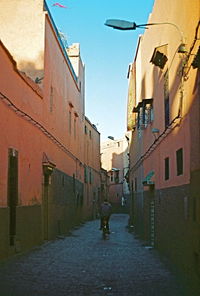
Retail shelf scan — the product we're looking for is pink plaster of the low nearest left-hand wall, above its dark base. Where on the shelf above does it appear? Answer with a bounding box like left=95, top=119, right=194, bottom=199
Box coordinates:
left=0, top=44, right=43, bottom=206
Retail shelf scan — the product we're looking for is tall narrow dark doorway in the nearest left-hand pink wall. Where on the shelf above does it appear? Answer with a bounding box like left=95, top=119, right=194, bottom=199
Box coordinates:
left=8, top=149, right=18, bottom=246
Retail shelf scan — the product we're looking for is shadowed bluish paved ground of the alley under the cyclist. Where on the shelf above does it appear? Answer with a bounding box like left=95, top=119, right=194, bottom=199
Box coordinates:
left=0, top=214, right=193, bottom=296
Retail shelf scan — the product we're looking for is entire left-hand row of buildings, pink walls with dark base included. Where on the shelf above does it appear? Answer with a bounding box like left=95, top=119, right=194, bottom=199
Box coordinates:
left=0, top=0, right=100, bottom=258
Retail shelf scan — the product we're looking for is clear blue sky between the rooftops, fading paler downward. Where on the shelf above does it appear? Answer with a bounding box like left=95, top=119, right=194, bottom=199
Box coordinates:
left=46, top=0, right=154, bottom=141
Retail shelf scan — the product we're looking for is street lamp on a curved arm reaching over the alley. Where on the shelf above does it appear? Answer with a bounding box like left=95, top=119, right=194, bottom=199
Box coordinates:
left=105, top=19, right=186, bottom=53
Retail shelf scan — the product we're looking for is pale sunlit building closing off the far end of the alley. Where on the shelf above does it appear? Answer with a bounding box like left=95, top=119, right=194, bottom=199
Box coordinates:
left=101, top=137, right=129, bottom=211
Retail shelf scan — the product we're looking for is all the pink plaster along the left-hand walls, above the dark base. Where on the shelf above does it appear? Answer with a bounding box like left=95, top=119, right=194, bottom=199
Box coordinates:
left=0, top=11, right=99, bottom=206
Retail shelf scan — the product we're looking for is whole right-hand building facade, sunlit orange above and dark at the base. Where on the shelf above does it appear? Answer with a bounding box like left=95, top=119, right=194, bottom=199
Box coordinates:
left=127, top=0, right=200, bottom=286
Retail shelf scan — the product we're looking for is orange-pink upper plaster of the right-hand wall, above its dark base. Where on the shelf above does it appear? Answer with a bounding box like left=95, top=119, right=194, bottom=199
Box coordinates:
left=131, top=0, right=199, bottom=189
